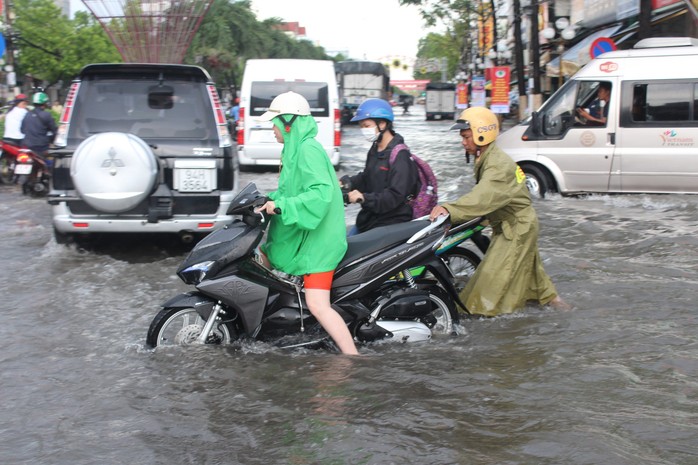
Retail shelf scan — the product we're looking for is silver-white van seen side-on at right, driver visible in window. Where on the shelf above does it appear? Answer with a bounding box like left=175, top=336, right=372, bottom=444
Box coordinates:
left=497, top=38, right=698, bottom=196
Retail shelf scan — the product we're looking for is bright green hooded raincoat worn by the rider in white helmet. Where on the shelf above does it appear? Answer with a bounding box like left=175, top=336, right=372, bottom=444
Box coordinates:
left=262, top=116, right=347, bottom=276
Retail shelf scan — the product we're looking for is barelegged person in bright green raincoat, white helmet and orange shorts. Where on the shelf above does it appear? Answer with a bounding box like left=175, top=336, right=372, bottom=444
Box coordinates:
left=257, top=92, right=358, bottom=355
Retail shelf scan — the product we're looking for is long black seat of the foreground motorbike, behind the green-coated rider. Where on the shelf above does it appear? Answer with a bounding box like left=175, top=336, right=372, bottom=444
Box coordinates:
left=337, top=220, right=430, bottom=269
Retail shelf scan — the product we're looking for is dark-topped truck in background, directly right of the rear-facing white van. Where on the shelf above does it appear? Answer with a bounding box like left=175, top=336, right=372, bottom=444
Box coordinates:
left=335, top=61, right=390, bottom=124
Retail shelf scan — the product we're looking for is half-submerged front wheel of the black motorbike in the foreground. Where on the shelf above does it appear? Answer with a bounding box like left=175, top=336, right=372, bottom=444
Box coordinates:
left=146, top=307, right=238, bottom=348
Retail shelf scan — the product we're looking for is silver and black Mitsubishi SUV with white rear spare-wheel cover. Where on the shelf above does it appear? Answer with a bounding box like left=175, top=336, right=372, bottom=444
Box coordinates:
left=48, top=64, right=238, bottom=243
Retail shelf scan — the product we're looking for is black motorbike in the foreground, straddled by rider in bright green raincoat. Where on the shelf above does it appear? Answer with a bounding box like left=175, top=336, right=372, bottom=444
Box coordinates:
left=146, top=183, right=479, bottom=347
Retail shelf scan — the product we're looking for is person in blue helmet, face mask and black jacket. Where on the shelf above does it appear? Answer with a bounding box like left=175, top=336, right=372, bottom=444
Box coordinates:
left=340, top=98, right=420, bottom=236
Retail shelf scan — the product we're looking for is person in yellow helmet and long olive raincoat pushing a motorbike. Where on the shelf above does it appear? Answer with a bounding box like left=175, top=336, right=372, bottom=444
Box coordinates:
left=430, top=107, right=567, bottom=316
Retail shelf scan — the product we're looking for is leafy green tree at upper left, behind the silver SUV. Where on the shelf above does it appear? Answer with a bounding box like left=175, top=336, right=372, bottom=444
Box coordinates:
left=13, top=0, right=121, bottom=85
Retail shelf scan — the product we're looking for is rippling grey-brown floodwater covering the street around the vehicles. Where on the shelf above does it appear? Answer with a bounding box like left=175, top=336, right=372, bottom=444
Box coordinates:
left=0, top=107, right=698, bottom=465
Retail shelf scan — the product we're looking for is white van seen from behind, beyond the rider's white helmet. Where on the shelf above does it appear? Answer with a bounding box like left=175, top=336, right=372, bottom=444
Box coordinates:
left=237, top=59, right=341, bottom=167
